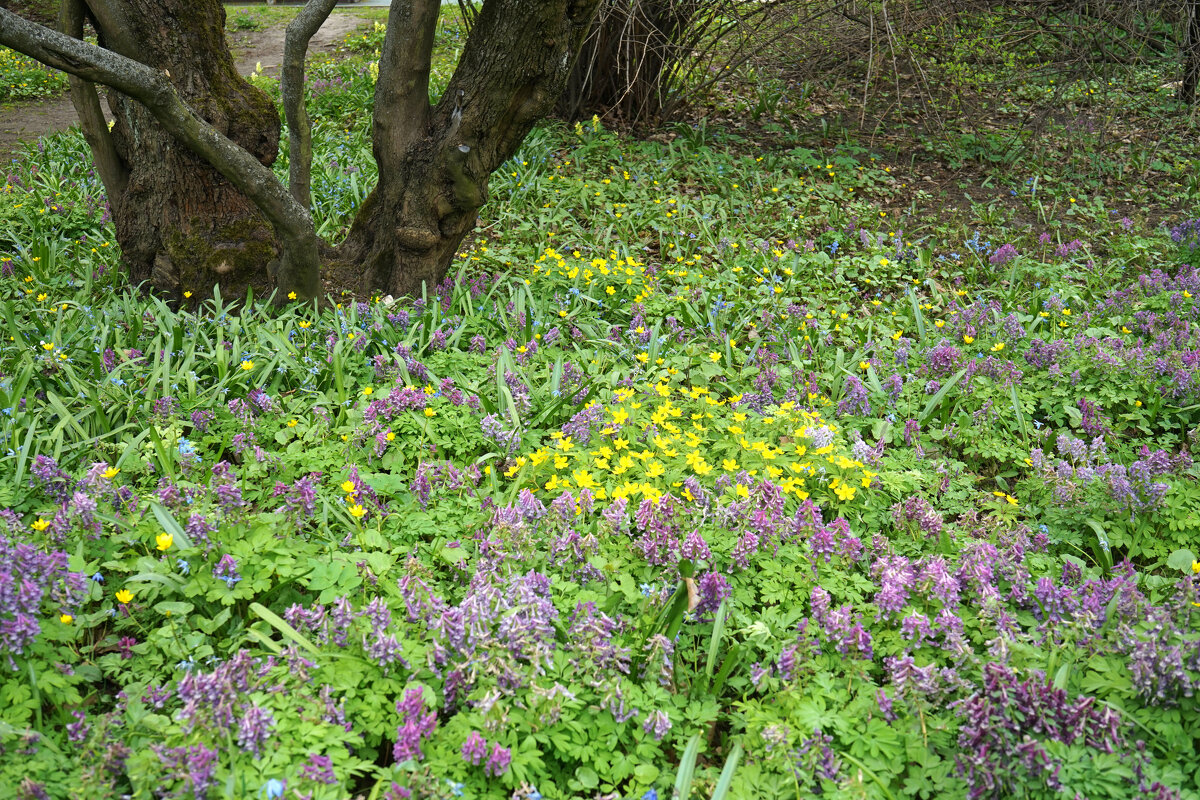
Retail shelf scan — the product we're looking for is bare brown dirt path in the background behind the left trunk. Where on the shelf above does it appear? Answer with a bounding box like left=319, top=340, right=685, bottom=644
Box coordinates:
left=0, top=11, right=368, bottom=163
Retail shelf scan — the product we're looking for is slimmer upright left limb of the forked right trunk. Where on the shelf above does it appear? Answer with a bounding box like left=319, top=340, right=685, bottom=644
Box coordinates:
left=373, top=0, right=442, bottom=172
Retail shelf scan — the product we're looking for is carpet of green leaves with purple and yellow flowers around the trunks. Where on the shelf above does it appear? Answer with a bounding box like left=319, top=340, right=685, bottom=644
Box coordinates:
left=0, top=6, right=1200, bottom=800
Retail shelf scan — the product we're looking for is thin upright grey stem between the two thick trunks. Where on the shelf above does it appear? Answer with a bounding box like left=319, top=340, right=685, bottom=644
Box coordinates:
left=281, top=0, right=337, bottom=209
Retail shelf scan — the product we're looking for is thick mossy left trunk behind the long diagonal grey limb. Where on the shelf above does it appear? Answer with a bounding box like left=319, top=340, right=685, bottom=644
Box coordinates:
left=88, top=0, right=280, bottom=297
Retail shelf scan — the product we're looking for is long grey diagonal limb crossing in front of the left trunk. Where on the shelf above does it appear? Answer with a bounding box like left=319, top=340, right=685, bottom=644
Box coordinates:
left=0, top=8, right=320, bottom=299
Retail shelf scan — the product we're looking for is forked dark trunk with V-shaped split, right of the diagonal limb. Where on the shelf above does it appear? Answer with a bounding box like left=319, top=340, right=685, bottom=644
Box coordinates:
left=337, top=0, right=598, bottom=295
